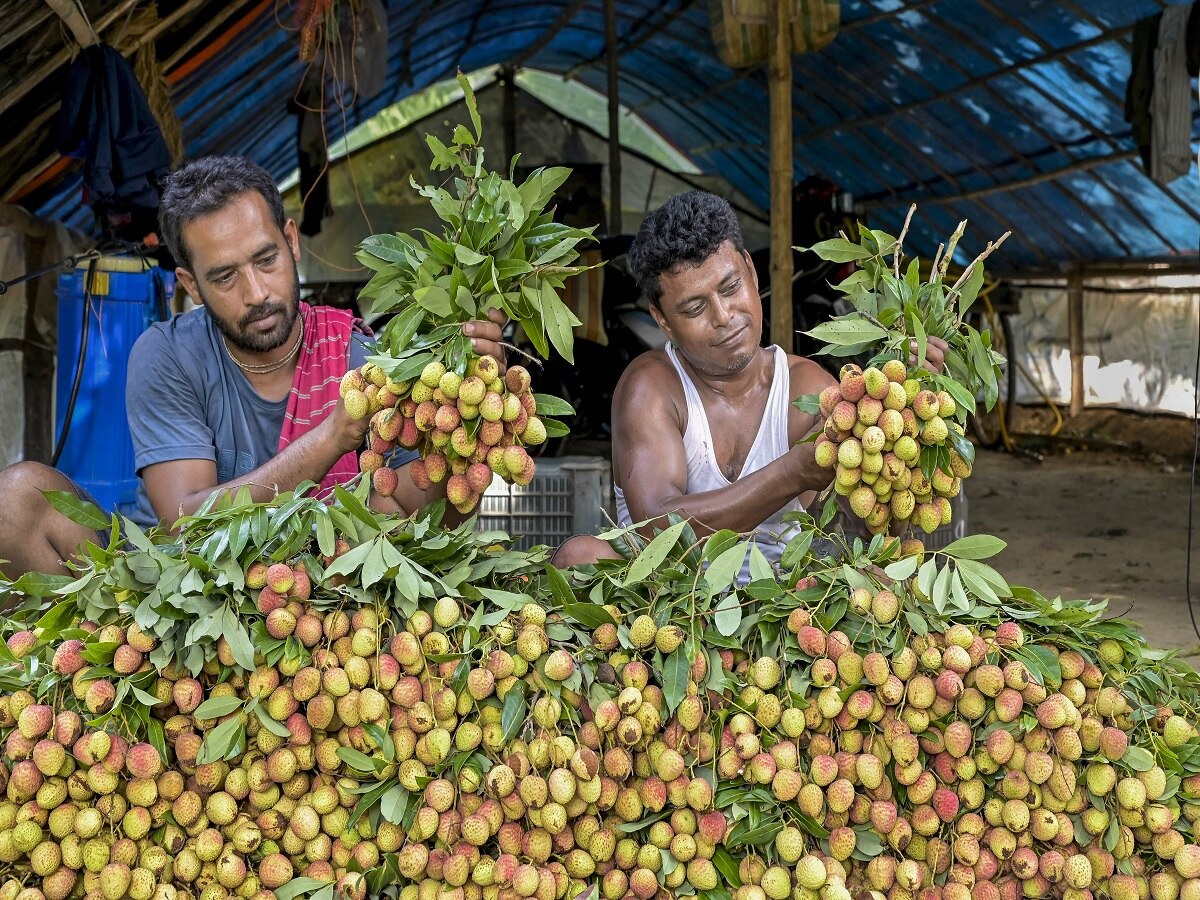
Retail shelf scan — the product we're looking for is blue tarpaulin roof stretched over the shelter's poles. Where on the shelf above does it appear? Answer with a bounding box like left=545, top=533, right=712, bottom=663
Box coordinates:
left=23, top=0, right=1200, bottom=270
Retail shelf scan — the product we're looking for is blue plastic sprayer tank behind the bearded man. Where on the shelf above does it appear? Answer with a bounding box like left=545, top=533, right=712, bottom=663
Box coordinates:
left=54, top=257, right=175, bottom=514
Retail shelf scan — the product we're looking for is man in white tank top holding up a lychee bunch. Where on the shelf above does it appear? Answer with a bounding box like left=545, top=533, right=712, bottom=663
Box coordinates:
left=556, top=191, right=944, bottom=580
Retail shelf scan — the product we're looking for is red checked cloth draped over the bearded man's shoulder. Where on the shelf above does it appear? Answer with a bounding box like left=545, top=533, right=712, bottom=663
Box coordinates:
left=280, top=302, right=359, bottom=492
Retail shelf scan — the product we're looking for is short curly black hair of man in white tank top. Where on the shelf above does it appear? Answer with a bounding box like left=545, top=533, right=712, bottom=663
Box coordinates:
left=629, top=191, right=744, bottom=306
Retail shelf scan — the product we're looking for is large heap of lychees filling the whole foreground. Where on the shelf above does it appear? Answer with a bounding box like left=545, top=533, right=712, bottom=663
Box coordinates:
left=0, top=520, right=1200, bottom=900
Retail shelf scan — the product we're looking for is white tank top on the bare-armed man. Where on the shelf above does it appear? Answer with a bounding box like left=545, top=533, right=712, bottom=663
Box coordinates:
left=614, top=343, right=804, bottom=584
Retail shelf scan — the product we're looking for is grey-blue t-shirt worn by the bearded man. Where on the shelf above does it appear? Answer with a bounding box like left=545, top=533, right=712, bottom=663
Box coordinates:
left=125, top=307, right=416, bottom=526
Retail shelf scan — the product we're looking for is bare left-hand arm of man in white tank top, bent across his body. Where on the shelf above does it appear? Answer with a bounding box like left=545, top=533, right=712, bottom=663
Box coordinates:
left=613, top=365, right=829, bottom=534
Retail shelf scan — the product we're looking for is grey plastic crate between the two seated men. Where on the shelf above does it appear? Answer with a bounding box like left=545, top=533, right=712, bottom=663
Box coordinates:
left=479, top=456, right=613, bottom=550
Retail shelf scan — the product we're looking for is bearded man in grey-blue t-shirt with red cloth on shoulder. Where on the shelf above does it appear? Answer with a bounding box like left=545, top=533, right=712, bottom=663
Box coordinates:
left=0, top=157, right=504, bottom=577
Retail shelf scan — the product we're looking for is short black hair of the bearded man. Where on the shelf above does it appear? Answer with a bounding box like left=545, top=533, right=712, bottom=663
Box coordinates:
left=158, top=156, right=286, bottom=269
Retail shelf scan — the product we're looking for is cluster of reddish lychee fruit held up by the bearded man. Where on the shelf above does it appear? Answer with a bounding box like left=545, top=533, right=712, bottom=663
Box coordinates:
left=341, top=356, right=546, bottom=514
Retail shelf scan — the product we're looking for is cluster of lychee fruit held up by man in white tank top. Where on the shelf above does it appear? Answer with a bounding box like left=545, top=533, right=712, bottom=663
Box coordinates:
left=814, top=360, right=971, bottom=534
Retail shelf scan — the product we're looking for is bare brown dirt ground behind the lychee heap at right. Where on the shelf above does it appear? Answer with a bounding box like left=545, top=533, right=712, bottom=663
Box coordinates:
left=966, top=448, right=1200, bottom=662
